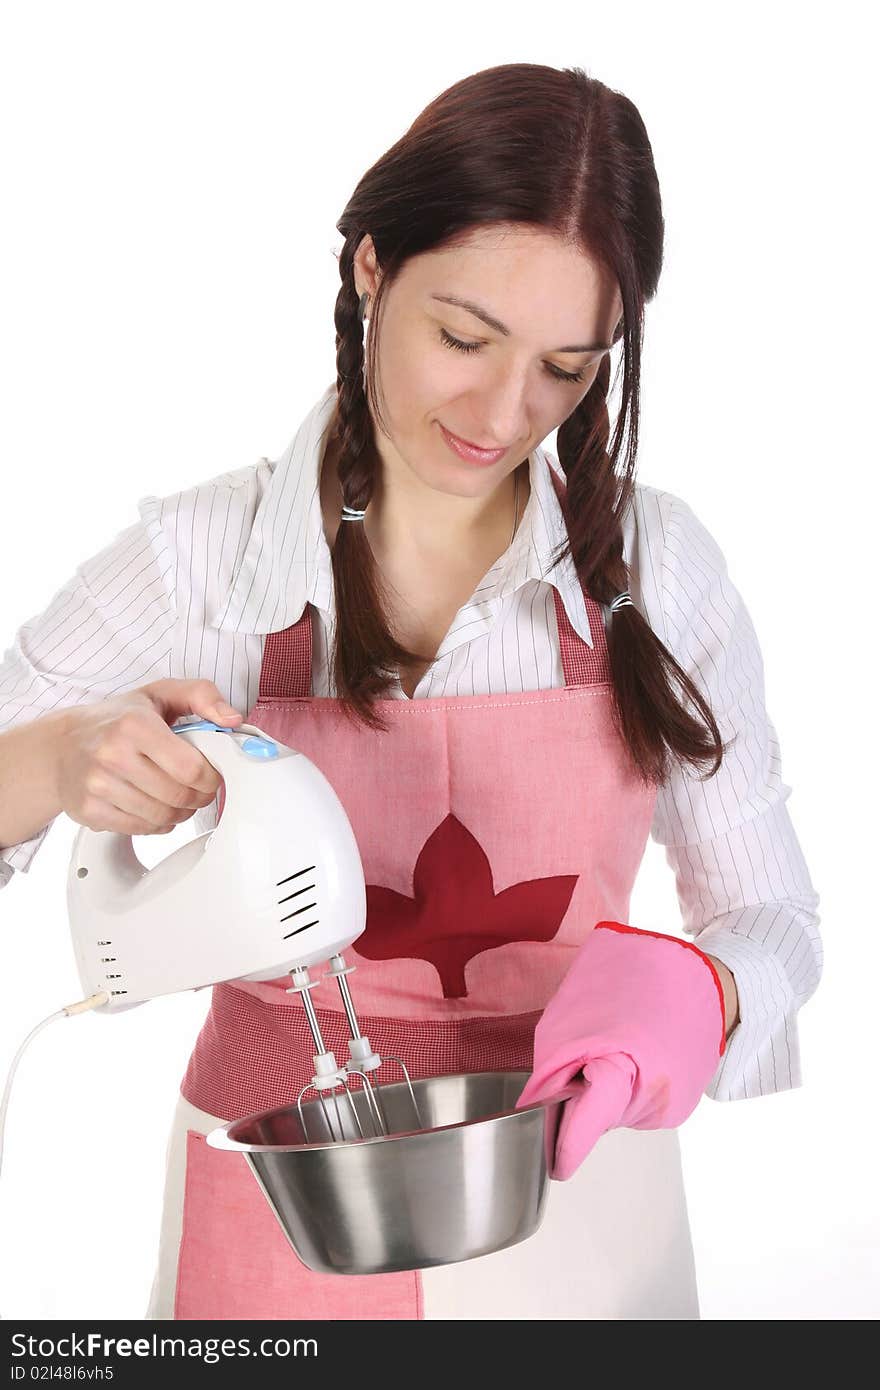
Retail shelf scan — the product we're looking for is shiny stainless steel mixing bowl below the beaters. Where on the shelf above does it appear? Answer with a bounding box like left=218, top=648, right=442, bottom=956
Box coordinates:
left=206, top=1072, right=574, bottom=1275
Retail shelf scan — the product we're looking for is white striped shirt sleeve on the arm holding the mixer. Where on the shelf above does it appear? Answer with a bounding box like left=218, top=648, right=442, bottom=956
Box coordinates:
left=0, top=498, right=177, bottom=888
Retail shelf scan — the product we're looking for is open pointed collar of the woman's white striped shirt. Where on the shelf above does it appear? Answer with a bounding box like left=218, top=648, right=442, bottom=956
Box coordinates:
left=206, top=382, right=594, bottom=656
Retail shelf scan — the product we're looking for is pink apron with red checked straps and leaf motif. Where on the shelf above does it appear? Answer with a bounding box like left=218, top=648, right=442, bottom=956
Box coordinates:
left=152, top=461, right=699, bottom=1319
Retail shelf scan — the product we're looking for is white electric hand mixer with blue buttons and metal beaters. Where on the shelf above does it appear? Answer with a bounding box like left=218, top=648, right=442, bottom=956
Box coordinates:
left=68, top=719, right=420, bottom=1140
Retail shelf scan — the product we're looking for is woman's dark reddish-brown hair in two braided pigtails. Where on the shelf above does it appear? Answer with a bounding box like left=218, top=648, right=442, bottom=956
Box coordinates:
left=322, top=63, right=726, bottom=783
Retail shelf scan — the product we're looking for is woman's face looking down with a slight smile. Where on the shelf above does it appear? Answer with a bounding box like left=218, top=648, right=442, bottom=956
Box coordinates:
left=355, top=224, right=623, bottom=498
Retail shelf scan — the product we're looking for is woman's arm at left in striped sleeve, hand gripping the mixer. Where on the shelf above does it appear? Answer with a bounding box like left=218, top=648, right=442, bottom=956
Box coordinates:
left=0, top=520, right=241, bottom=887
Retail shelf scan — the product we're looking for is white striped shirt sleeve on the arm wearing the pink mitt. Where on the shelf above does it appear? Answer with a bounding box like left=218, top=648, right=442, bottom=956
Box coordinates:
left=633, top=489, right=823, bottom=1101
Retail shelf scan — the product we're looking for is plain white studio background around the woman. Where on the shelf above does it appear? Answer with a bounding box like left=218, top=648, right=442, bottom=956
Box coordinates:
left=0, top=0, right=880, bottom=1319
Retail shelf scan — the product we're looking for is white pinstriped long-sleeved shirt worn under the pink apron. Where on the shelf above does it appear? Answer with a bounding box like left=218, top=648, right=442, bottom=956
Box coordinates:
left=0, top=384, right=822, bottom=1101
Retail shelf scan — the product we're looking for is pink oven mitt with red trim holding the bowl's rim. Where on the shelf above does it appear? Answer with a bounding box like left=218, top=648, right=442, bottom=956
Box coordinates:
left=516, top=922, right=724, bottom=1180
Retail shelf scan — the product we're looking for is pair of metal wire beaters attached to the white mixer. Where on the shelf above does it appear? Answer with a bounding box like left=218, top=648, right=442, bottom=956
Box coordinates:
left=285, top=954, right=424, bottom=1144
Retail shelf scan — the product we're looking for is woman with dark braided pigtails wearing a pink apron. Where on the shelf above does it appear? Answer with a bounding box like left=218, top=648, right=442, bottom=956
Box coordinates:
left=0, top=64, right=822, bottom=1319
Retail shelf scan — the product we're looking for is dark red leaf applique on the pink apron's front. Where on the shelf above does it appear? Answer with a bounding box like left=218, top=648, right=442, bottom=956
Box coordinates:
left=356, top=815, right=578, bottom=999
